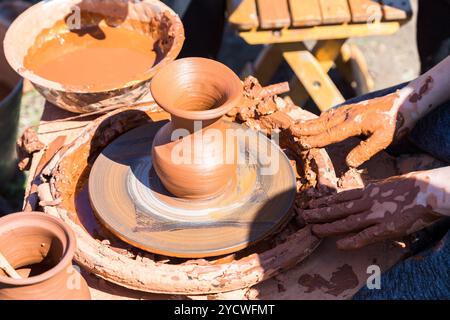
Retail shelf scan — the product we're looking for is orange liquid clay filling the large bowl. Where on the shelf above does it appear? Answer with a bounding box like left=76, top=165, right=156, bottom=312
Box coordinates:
left=24, top=24, right=158, bottom=87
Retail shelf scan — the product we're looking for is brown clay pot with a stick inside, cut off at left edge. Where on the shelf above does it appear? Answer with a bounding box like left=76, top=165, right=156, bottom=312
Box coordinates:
left=0, top=212, right=91, bottom=300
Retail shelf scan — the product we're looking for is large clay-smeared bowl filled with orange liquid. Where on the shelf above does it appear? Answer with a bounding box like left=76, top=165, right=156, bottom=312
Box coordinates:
left=4, top=0, right=184, bottom=113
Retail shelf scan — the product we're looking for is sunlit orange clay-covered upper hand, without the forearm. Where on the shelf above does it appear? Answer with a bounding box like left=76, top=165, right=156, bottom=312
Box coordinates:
left=290, top=93, right=404, bottom=167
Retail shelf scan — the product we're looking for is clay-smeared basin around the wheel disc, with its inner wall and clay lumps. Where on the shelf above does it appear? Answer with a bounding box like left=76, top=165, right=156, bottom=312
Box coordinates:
left=37, top=78, right=336, bottom=294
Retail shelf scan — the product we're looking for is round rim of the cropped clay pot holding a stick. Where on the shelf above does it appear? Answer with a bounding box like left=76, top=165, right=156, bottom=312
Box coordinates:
left=0, top=212, right=76, bottom=286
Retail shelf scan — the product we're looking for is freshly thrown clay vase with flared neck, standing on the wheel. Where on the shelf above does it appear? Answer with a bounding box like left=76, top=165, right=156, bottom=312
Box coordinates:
left=150, top=58, right=243, bottom=199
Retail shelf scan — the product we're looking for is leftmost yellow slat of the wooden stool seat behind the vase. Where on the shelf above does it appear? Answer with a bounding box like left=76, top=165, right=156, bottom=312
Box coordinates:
left=227, top=0, right=259, bottom=30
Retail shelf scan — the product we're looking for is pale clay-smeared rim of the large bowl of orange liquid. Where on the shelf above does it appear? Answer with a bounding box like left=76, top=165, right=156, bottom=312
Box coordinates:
left=4, top=0, right=185, bottom=93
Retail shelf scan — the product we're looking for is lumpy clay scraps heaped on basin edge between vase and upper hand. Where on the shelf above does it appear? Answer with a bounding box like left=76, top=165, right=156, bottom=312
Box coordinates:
left=228, top=77, right=337, bottom=196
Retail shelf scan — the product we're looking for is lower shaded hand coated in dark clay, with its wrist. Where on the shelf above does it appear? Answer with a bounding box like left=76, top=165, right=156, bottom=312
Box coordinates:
left=302, top=167, right=450, bottom=249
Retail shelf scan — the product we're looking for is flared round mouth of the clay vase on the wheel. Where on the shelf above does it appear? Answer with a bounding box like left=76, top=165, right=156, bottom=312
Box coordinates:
left=150, top=58, right=243, bottom=120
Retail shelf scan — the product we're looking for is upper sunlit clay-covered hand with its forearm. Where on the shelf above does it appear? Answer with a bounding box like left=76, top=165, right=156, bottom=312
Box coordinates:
left=290, top=56, right=450, bottom=167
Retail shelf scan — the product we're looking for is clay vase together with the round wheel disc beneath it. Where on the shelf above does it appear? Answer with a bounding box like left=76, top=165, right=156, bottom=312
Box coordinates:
left=88, top=58, right=296, bottom=258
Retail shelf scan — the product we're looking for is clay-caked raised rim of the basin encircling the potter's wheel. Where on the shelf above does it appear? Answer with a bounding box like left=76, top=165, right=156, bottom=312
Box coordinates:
left=39, top=105, right=336, bottom=295
